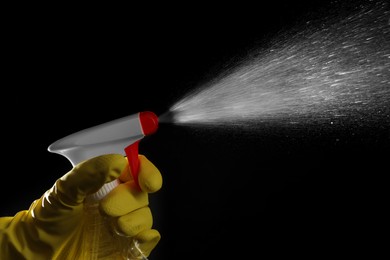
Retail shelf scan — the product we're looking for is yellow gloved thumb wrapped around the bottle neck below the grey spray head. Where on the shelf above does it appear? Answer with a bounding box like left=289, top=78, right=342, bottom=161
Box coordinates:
left=56, top=154, right=127, bottom=204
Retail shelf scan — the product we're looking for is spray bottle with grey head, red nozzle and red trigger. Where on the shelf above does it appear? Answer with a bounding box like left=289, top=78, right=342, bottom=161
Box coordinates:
left=48, top=111, right=158, bottom=260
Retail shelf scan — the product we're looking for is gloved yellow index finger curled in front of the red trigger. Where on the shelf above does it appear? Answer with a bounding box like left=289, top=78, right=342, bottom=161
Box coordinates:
left=138, top=155, right=162, bottom=193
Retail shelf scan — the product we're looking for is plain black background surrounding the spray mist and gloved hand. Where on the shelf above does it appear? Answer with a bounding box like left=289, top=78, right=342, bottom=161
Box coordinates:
left=1, top=1, right=390, bottom=259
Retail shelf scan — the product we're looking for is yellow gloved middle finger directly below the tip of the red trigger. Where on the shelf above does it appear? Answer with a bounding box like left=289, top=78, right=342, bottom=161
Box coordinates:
left=100, top=181, right=149, bottom=217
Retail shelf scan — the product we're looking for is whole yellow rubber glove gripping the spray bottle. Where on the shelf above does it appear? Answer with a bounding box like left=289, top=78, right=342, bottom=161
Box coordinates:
left=0, top=154, right=162, bottom=260
